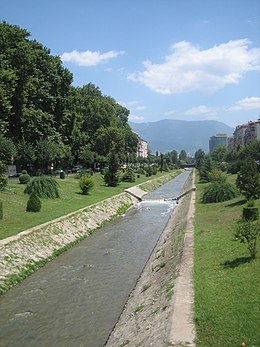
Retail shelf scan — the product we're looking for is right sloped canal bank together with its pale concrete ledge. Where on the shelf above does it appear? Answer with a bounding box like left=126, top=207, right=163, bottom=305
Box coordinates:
left=106, top=171, right=195, bottom=347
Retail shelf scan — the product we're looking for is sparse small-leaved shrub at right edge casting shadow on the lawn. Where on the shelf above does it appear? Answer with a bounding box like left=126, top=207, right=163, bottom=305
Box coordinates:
left=235, top=219, right=260, bottom=259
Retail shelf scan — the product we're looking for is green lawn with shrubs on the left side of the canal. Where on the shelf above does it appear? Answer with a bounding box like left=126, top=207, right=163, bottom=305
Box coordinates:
left=0, top=172, right=179, bottom=239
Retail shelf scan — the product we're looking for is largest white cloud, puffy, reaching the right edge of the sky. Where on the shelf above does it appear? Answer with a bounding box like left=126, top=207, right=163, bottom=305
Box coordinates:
left=128, top=39, right=260, bottom=95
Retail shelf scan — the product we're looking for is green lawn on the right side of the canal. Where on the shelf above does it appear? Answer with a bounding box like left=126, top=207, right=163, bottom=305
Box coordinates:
left=194, top=176, right=260, bottom=347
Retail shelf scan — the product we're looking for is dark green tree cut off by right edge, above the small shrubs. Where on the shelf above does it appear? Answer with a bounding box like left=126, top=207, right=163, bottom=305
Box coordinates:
left=236, top=158, right=260, bottom=200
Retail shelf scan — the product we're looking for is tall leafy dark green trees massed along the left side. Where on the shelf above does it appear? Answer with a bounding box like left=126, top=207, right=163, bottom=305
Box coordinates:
left=0, top=22, right=138, bottom=170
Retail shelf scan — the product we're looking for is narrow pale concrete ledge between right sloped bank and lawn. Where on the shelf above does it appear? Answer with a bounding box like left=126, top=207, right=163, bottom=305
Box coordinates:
left=170, top=171, right=195, bottom=347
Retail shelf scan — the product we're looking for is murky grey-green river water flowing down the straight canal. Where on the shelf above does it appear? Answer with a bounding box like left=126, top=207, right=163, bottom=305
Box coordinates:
left=0, top=171, right=190, bottom=347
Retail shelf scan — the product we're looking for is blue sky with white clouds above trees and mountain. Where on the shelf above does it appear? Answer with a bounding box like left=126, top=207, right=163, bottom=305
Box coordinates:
left=0, top=0, right=260, bottom=127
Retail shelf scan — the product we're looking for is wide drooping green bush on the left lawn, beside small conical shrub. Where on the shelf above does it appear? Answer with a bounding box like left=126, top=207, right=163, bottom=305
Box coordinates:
left=24, top=176, right=60, bottom=199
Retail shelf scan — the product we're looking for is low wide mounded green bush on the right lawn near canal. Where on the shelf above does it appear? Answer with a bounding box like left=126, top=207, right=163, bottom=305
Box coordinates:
left=202, top=181, right=238, bottom=204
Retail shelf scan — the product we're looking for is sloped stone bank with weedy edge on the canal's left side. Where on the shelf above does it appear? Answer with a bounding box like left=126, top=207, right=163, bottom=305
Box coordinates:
left=0, top=171, right=179, bottom=294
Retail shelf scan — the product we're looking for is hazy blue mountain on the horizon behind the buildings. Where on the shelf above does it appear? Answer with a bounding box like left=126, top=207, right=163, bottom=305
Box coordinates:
left=129, top=119, right=234, bottom=154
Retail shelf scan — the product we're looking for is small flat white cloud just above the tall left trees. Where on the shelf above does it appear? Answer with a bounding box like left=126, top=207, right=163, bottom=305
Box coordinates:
left=61, top=50, right=125, bottom=66
